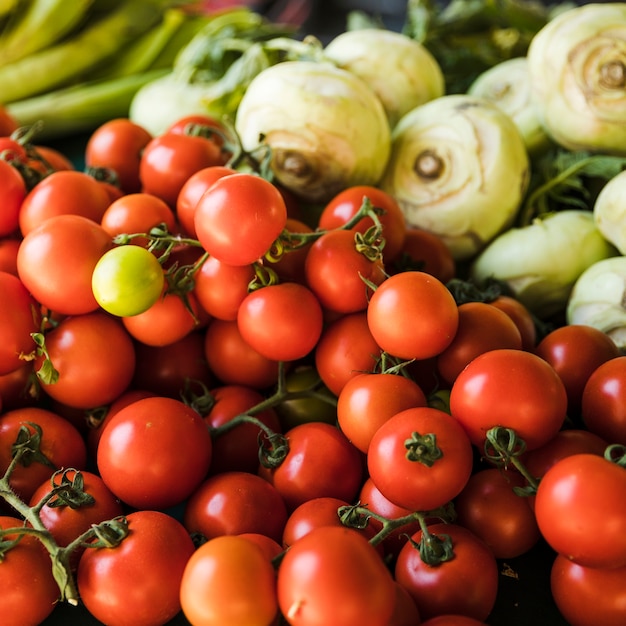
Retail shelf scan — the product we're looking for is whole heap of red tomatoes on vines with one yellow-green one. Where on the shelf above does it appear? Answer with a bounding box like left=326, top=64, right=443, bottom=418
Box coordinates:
left=0, top=107, right=626, bottom=626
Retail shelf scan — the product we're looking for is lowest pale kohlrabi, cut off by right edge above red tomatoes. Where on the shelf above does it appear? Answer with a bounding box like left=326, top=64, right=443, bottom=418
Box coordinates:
left=566, top=256, right=626, bottom=351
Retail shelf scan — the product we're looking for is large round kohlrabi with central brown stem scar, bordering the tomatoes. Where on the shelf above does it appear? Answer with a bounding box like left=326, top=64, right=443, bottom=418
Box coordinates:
left=380, top=94, right=529, bottom=260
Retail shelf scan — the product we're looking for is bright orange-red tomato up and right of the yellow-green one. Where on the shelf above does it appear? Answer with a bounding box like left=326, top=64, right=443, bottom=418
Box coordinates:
left=194, top=172, right=287, bottom=265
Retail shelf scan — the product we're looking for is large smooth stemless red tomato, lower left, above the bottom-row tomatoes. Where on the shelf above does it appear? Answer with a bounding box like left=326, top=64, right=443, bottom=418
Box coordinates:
left=97, top=396, right=212, bottom=509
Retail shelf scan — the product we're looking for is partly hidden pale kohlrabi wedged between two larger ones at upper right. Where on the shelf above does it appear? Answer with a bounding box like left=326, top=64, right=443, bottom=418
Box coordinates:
left=467, top=57, right=551, bottom=154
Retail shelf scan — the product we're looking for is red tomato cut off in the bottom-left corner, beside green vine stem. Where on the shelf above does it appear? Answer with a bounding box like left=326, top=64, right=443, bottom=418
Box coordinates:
left=0, top=516, right=59, bottom=626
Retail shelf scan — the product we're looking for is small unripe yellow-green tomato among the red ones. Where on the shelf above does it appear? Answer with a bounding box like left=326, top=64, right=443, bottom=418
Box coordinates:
left=91, top=245, right=165, bottom=317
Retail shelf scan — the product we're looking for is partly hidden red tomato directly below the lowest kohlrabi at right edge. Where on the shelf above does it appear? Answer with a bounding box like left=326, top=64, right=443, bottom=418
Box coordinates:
left=535, top=324, right=620, bottom=416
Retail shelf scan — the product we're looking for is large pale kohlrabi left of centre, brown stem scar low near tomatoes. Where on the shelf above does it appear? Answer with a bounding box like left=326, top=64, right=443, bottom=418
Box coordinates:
left=235, top=61, right=391, bottom=202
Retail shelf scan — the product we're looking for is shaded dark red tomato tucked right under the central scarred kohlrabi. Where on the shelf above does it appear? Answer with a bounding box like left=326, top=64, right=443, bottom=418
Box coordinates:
left=387, top=227, right=456, bottom=283
